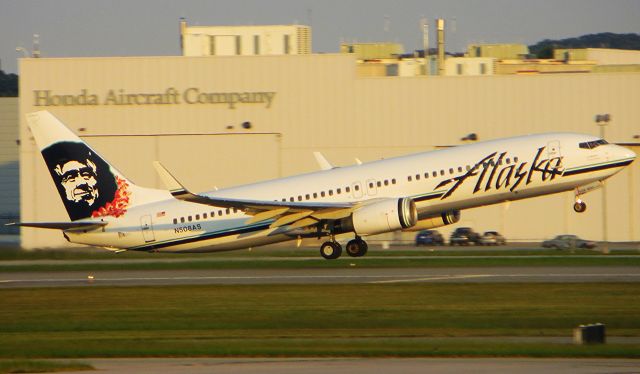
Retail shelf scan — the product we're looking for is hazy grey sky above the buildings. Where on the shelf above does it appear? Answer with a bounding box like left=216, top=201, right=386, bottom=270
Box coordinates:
left=0, top=0, right=640, bottom=73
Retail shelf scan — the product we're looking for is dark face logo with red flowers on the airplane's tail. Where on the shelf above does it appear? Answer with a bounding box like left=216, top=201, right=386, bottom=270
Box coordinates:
left=42, top=142, right=129, bottom=220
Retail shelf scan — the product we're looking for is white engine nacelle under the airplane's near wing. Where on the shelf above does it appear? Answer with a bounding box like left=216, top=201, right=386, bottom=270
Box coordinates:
left=338, top=198, right=418, bottom=235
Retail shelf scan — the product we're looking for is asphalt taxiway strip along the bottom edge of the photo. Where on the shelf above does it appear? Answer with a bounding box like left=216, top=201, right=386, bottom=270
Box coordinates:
left=51, top=358, right=640, bottom=374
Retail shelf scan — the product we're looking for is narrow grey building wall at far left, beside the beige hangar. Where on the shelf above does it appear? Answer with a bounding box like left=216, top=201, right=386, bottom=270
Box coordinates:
left=0, top=97, right=20, bottom=233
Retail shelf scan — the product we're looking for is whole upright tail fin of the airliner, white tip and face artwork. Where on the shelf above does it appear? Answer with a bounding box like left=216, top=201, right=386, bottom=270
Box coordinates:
left=27, top=111, right=157, bottom=221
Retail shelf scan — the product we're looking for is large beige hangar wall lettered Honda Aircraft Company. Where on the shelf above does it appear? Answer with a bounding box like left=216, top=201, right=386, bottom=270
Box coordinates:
left=20, top=54, right=640, bottom=247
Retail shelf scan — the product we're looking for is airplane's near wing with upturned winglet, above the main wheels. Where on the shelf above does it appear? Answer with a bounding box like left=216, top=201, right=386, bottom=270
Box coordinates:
left=153, top=161, right=360, bottom=228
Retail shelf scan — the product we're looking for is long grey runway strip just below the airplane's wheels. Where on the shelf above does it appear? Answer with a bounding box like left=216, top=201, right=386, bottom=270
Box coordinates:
left=0, top=266, right=640, bottom=288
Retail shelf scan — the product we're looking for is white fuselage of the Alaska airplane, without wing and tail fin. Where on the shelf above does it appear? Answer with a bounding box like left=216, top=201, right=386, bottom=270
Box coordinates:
left=65, top=133, right=635, bottom=252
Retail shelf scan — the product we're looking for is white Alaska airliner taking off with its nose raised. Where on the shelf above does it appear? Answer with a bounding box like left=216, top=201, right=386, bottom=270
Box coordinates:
left=15, top=111, right=636, bottom=260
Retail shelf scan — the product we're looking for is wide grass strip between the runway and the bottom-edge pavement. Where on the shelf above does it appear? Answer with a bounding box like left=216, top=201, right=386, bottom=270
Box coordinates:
left=0, top=283, right=640, bottom=358
